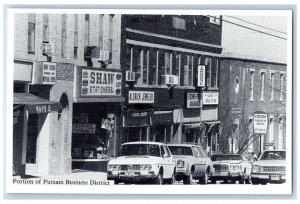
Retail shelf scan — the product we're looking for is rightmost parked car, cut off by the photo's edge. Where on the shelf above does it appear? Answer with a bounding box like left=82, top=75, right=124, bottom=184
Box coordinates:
left=251, top=150, right=286, bottom=185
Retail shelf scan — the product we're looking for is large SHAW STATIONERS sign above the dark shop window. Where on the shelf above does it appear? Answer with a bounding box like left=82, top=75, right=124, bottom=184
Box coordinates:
left=81, top=69, right=122, bottom=96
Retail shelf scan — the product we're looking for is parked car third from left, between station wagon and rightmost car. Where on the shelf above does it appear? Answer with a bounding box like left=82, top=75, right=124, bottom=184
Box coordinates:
left=210, top=154, right=252, bottom=184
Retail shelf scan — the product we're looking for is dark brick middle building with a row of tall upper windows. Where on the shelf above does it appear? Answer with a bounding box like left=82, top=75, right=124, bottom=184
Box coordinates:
left=121, top=15, right=222, bottom=155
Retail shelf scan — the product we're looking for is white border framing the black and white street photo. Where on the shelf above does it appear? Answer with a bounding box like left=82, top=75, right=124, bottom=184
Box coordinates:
left=5, top=7, right=296, bottom=195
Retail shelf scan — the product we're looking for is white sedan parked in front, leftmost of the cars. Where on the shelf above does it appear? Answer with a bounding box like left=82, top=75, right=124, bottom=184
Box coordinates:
left=107, top=142, right=175, bottom=184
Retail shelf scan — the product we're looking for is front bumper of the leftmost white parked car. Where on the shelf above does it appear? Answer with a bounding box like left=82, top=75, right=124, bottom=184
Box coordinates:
left=107, top=171, right=157, bottom=182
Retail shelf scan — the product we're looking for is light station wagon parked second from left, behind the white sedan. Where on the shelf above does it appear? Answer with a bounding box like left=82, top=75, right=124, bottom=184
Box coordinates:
left=168, top=144, right=213, bottom=184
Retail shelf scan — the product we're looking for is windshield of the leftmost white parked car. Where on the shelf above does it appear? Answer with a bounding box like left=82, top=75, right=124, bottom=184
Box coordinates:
left=120, top=144, right=160, bottom=157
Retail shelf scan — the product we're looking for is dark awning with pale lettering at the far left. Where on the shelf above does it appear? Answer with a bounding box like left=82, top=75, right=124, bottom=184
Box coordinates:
left=14, top=93, right=62, bottom=114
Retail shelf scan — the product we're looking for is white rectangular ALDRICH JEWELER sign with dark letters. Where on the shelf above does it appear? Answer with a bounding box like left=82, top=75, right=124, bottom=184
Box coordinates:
left=128, top=91, right=154, bottom=103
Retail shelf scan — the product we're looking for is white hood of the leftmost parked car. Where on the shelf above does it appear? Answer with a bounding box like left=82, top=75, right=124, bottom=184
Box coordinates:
left=108, top=156, right=161, bottom=164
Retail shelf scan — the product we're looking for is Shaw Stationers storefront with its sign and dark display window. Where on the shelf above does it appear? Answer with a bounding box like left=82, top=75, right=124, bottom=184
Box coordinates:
left=72, top=67, right=125, bottom=170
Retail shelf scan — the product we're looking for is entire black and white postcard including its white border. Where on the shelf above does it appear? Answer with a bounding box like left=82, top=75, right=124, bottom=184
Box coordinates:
left=1, top=1, right=293, bottom=198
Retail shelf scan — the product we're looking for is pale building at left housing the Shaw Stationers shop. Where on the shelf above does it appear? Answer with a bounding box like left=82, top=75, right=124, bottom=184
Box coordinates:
left=13, top=13, right=124, bottom=175
